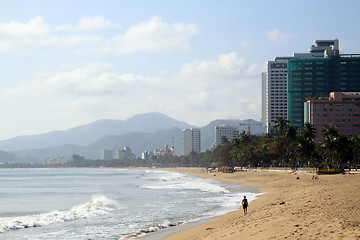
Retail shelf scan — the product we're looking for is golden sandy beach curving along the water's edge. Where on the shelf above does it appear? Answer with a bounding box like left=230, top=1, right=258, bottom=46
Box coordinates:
left=160, top=168, right=360, bottom=240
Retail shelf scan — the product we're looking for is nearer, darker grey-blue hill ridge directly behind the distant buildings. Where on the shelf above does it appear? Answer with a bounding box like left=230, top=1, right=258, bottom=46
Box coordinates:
left=9, top=120, right=265, bottom=161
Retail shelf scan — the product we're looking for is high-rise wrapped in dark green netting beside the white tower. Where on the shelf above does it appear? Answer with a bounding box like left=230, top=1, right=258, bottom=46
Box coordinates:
left=287, top=51, right=360, bottom=127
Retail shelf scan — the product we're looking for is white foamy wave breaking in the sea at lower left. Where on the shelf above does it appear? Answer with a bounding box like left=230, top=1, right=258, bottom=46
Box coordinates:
left=0, top=196, right=119, bottom=232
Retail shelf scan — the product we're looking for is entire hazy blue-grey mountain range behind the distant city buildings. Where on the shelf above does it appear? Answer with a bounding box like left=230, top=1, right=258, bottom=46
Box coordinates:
left=0, top=113, right=265, bottom=163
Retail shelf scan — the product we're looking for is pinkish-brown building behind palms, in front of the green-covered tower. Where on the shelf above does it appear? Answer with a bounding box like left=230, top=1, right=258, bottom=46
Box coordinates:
left=304, top=92, right=360, bottom=140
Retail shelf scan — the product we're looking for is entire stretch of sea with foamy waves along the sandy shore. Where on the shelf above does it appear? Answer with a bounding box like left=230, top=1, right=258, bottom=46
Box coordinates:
left=0, top=169, right=257, bottom=240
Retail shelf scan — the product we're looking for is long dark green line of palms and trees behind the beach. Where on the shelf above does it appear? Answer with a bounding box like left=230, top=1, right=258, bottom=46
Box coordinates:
left=0, top=117, right=360, bottom=169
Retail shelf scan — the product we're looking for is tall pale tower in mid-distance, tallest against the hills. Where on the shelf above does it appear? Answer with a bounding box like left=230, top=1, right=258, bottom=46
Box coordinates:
left=182, top=128, right=201, bottom=155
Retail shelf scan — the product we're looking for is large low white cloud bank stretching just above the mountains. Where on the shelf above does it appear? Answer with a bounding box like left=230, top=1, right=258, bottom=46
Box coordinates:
left=0, top=53, right=261, bottom=139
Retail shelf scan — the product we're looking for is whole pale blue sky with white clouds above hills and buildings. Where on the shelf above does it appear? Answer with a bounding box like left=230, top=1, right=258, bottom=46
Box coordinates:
left=0, top=0, right=360, bottom=140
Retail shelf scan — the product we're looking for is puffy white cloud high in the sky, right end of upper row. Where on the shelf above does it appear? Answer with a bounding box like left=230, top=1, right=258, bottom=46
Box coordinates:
left=107, top=16, right=199, bottom=54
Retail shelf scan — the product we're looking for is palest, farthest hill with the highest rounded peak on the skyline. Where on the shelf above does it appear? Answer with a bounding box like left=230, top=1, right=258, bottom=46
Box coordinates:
left=0, top=113, right=192, bottom=151
